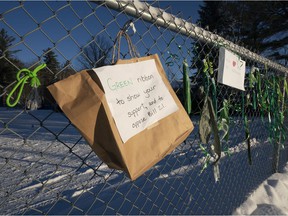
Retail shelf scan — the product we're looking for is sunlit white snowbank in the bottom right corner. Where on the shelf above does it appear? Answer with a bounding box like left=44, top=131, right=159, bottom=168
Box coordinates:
left=233, top=163, right=288, bottom=215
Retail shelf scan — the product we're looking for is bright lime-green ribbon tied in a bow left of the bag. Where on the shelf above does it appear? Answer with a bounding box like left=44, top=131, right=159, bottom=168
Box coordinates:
left=6, top=64, right=46, bottom=107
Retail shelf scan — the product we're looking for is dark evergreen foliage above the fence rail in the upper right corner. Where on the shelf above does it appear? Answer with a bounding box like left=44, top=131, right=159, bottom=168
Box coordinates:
left=199, top=1, right=288, bottom=65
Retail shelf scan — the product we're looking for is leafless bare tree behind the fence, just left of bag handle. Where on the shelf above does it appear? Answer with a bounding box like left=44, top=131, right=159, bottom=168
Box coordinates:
left=78, top=36, right=112, bottom=69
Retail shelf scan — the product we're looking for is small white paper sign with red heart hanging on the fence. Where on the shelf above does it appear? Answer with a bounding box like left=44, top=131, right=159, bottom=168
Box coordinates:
left=218, top=47, right=246, bottom=91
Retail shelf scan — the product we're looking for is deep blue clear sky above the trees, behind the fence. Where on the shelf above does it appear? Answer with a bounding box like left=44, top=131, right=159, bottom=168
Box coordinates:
left=0, top=1, right=202, bottom=75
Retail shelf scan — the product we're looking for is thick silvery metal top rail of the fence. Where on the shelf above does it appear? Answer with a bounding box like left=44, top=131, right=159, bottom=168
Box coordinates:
left=97, top=0, right=288, bottom=73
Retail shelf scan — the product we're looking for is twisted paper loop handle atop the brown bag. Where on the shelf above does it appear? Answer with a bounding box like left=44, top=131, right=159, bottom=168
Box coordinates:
left=112, top=30, right=138, bottom=64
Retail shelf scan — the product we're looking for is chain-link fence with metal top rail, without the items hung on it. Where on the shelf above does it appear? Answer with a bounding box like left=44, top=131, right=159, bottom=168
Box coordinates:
left=0, top=1, right=288, bottom=214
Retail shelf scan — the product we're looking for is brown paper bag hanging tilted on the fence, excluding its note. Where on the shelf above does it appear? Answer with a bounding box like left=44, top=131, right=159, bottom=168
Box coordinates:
left=48, top=42, right=194, bottom=180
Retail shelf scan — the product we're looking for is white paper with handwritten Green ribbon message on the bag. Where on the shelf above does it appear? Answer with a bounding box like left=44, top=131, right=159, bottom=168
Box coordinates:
left=93, top=59, right=178, bottom=143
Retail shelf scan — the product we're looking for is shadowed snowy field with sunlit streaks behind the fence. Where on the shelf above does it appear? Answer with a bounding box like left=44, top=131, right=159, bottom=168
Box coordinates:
left=0, top=108, right=288, bottom=214
